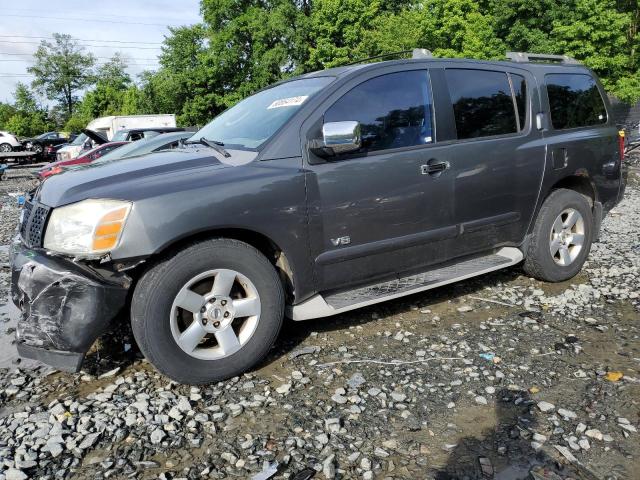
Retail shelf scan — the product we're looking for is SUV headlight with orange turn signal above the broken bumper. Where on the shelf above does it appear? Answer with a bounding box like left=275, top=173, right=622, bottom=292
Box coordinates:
left=44, top=199, right=131, bottom=255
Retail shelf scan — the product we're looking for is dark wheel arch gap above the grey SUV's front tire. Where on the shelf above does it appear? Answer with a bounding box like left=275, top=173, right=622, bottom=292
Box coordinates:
left=145, top=228, right=296, bottom=303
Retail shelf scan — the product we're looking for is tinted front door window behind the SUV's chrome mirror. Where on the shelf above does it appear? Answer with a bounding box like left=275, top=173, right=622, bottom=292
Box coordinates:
left=324, top=70, right=433, bottom=151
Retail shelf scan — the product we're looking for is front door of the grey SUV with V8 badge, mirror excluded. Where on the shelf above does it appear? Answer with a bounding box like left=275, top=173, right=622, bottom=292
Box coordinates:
left=307, top=68, right=456, bottom=291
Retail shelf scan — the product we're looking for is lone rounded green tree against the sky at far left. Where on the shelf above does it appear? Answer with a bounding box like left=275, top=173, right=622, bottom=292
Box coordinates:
left=27, top=33, right=95, bottom=116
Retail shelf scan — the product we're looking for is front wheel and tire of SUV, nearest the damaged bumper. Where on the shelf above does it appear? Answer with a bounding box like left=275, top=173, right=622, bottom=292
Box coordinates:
left=131, top=238, right=284, bottom=385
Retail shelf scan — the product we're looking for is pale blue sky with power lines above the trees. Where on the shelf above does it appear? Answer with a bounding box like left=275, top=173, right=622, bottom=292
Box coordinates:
left=0, top=0, right=201, bottom=103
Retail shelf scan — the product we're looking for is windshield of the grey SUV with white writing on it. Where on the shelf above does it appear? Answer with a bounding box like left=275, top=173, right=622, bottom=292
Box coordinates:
left=190, top=77, right=333, bottom=149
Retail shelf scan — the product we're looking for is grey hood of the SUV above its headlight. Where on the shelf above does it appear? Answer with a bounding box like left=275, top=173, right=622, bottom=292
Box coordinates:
left=38, top=149, right=235, bottom=207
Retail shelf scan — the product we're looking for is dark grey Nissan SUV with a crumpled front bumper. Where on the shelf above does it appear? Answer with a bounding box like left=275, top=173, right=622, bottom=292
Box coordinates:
left=12, top=50, right=626, bottom=384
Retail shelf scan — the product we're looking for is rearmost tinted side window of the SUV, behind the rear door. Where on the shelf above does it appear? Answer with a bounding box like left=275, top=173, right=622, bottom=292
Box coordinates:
left=545, top=73, right=607, bottom=130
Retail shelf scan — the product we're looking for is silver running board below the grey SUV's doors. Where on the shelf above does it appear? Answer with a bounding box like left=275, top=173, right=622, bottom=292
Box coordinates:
left=287, top=247, right=524, bottom=320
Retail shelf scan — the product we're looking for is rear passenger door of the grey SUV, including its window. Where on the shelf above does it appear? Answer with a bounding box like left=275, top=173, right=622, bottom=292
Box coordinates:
left=445, top=64, right=545, bottom=256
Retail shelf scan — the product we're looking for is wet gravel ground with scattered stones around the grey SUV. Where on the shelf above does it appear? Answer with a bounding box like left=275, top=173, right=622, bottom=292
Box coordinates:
left=0, top=166, right=640, bottom=480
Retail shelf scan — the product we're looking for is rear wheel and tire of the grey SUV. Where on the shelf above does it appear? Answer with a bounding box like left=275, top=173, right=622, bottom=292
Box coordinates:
left=524, top=189, right=593, bottom=282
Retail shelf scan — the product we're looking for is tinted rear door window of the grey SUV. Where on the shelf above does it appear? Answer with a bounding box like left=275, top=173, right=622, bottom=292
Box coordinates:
left=445, top=69, right=518, bottom=139
